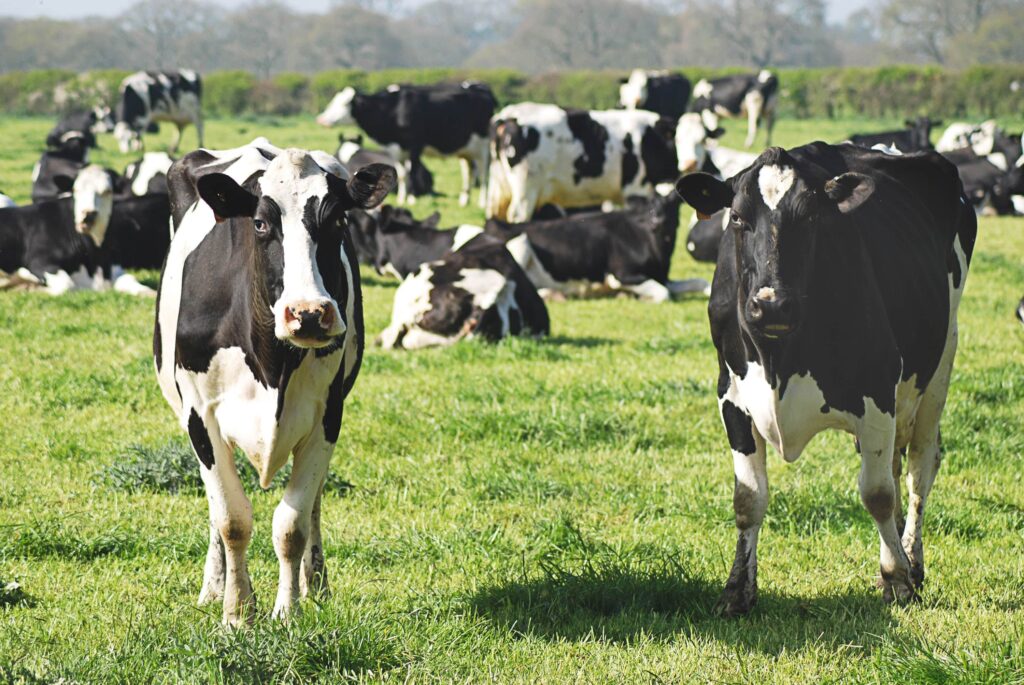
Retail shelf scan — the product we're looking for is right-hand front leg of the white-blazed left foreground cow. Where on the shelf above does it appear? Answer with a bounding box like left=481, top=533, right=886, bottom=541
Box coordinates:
left=273, top=433, right=334, bottom=618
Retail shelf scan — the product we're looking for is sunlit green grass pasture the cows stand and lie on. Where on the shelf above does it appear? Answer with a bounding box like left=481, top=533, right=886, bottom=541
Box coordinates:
left=0, top=114, right=1024, bottom=683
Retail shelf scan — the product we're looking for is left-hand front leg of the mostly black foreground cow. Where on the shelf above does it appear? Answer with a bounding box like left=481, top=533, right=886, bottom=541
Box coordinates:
left=719, top=399, right=768, bottom=616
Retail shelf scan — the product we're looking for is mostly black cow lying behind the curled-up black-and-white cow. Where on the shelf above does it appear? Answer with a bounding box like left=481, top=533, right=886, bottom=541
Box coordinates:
left=484, top=192, right=708, bottom=302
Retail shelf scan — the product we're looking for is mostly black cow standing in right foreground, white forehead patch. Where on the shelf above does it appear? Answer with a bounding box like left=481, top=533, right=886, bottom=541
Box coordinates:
left=678, top=142, right=977, bottom=615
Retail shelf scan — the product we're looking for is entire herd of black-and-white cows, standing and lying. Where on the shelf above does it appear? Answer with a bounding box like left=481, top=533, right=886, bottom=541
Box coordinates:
left=0, top=65, right=1024, bottom=625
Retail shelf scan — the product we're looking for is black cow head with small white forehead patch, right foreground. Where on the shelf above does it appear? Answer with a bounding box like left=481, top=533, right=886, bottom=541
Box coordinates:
left=676, top=147, right=874, bottom=341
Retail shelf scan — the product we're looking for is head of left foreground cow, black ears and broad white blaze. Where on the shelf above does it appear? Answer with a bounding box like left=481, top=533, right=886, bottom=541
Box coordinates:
left=197, top=148, right=395, bottom=348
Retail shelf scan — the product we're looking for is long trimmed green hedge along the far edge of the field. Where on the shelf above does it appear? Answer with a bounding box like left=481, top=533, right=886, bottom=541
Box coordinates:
left=6, top=65, right=1024, bottom=119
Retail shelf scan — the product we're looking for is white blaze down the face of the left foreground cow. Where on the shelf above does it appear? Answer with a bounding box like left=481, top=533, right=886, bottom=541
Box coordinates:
left=259, top=148, right=345, bottom=340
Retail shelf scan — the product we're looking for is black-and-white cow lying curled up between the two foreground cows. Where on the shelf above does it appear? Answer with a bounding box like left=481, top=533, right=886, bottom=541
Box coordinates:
left=378, top=236, right=551, bottom=349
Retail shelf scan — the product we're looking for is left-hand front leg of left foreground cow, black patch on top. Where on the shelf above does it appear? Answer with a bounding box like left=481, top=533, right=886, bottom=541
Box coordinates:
left=188, top=412, right=256, bottom=626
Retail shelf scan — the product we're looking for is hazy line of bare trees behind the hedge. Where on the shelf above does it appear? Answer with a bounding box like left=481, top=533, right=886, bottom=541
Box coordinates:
left=0, top=0, right=1024, bottom=79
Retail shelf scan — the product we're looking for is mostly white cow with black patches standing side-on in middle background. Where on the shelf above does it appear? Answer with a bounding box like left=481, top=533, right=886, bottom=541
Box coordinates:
left=486, top=102, right=679, bottom=222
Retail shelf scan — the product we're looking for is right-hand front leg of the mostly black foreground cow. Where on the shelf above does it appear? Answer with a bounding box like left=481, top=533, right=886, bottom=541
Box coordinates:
left=857, top=401, right=914, bottom=603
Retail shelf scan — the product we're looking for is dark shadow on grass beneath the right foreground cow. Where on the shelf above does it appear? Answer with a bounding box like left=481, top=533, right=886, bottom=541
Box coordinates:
left=469, top=571, right=896, bottom=655
